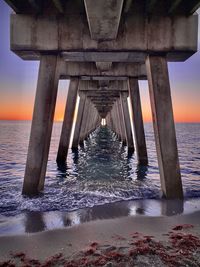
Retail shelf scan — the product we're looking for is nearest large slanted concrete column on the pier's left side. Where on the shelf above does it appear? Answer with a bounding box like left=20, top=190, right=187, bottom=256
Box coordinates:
left=22, top=55, right=60, bottom=195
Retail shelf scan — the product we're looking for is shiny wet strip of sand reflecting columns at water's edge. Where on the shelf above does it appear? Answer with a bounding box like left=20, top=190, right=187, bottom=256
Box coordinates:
left=3, top=200, right=189, bottom=235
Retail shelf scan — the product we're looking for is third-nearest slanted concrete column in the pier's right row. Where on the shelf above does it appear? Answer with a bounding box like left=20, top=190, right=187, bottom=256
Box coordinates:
left=120, top=92, right=134, bottom=152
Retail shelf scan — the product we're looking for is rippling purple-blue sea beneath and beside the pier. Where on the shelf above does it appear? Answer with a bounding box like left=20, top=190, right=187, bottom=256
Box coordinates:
left=0, top=121, right=200, bottom=216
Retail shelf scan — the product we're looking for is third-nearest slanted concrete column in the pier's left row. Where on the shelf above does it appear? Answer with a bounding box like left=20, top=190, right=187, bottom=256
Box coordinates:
left=72, top=91, right=86, bottom=149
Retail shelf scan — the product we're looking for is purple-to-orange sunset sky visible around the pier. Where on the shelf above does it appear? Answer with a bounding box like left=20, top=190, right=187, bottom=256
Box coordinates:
left=0, top=0, right=200, bottom=122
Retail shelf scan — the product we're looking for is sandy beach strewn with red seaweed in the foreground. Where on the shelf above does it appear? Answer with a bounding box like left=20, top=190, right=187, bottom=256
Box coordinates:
left=0, top=207, right=200, bottom=267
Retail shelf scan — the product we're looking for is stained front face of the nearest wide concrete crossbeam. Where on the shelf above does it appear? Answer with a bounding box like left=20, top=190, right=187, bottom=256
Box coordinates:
left=11, top=12, right=198, bottom=62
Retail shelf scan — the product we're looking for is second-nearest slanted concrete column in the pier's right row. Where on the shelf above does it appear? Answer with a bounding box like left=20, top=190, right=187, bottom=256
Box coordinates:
left=128, top=79, right=148, bottom=165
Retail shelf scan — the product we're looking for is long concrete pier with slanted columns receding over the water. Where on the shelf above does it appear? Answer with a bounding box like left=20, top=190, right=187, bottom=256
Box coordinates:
left=5, top=0, right=200, bottom=199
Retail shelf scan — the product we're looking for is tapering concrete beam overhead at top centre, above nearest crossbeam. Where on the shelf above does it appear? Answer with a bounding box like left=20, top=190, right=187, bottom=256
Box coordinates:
left=84, top=0, right=123, bottom=41
